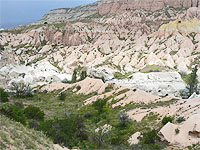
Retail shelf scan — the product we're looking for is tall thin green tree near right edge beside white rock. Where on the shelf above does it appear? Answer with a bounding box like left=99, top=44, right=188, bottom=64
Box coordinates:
left=185, top=65, right=198, bottom=96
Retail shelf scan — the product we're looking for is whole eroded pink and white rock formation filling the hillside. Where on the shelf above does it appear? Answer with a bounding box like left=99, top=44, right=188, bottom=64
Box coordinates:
left=0, top=0, right=200, bottom=96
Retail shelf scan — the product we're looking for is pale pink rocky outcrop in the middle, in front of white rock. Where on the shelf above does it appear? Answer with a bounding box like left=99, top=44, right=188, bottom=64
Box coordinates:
left=42, top=77, right=171, bottom=108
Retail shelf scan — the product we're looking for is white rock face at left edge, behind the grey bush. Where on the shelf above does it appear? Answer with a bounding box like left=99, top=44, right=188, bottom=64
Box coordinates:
left=0, top=61, right=71, bottom=88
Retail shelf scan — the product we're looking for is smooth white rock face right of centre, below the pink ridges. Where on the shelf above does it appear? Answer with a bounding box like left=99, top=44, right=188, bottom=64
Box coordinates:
left=110, top=72, right=185, bottom=96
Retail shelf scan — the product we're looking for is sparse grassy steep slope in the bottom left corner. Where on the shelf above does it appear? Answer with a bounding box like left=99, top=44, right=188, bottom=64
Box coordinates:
left=0, top=115, right=55, bottom=150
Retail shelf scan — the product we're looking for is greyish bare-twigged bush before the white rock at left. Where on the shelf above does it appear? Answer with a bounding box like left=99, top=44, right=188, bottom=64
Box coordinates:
left=10, top=81, right=34, bottom=97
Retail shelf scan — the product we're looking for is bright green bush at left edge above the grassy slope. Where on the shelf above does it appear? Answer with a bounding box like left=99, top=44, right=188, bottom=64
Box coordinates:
left=0, top=104, right=26, bottom=125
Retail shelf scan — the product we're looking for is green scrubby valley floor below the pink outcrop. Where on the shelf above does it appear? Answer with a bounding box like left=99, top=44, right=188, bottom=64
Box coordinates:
left=0, top=87, right=172, bottom=150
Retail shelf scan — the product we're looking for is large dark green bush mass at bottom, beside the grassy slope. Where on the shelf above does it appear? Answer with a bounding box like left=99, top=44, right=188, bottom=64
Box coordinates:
left=38, top=115, right=87, bottom=148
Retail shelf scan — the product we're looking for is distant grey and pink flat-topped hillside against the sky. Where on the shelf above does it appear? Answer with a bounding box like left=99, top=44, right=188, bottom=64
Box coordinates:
left=36, top=0, right=200, bottom=24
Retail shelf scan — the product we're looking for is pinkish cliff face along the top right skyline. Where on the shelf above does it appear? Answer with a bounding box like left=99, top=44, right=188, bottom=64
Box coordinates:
left=97, top=0, right=198, bottom=15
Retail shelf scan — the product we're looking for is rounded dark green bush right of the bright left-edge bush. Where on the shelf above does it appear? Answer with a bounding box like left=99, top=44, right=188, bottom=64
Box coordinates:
left=24, top=105, right=45, bottom=121
